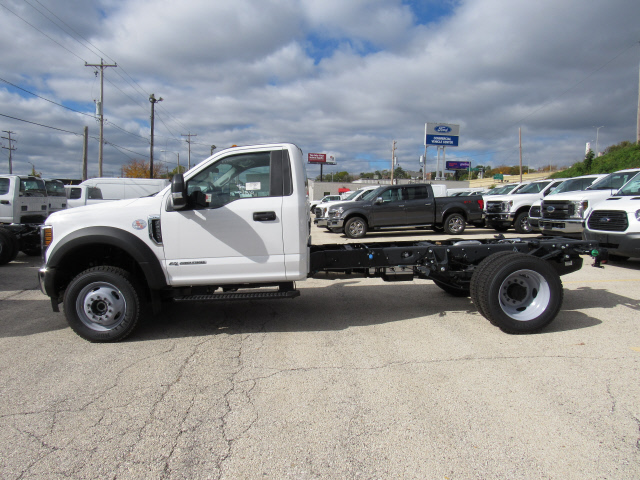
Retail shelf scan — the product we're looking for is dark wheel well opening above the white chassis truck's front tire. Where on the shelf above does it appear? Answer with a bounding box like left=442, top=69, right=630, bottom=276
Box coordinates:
left=55, top=243, right=150, bottom=304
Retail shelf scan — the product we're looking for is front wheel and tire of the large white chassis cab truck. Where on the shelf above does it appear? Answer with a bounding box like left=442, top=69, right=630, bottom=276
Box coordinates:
left=64, top=266, right=141, bottom=342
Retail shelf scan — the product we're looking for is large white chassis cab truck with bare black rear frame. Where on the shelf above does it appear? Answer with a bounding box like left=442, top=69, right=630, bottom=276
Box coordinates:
left=39, top=143, right=598, bottom=342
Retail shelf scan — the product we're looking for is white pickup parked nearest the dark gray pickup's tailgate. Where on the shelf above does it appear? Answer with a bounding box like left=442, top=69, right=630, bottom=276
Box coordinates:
left=485, top=178, right=565, bottom=233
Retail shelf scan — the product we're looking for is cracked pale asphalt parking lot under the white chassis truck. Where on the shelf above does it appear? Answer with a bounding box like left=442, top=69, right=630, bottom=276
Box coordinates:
left=0, top=227, right=640, bottom=480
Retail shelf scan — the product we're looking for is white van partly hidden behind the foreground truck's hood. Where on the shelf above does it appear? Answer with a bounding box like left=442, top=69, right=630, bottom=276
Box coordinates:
left=65, top=177, right=169, bottom=208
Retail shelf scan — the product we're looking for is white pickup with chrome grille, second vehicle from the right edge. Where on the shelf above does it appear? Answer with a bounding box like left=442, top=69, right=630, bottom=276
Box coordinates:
left=539, top=168, right=640, bottom=238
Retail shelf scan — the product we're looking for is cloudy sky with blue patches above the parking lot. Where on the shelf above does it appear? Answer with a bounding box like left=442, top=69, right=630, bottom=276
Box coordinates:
left=0, top=0, right=640, bottom=178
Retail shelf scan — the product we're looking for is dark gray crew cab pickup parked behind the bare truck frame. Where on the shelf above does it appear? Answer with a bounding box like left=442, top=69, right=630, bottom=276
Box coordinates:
left=327, top=183, right=484, bottom=238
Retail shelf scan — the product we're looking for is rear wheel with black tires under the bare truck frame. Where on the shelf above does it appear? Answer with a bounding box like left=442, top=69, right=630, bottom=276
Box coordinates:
left=471, top=252, right=563, bottom=333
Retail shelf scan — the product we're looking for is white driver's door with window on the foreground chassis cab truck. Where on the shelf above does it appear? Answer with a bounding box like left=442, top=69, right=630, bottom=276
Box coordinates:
left=161, top=149, right=288, bottom=285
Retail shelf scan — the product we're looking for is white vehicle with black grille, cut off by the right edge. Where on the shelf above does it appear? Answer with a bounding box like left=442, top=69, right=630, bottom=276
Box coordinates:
left=584, top=174, right=640, bottom=260
